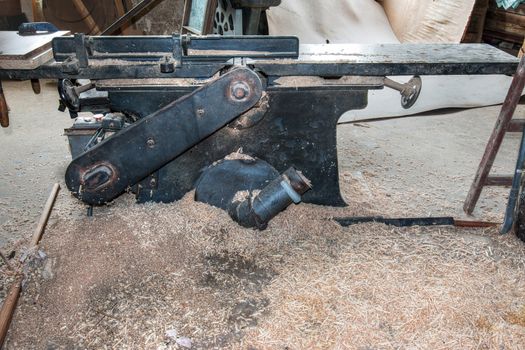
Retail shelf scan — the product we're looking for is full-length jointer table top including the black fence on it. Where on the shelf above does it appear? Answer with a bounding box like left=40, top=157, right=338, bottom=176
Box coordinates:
left=0, top=35, right=518, bottom=79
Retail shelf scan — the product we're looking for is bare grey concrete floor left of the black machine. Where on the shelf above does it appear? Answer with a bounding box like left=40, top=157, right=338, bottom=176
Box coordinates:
left=0, top=81, right=71, bottom=246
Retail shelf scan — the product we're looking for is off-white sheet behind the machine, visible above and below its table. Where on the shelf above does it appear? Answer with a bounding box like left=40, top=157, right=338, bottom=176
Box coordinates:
left=268, top=0, right=512, bottom=121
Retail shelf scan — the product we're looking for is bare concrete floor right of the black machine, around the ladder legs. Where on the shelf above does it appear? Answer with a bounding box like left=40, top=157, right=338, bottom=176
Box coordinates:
left=338, top=105, right=525, bottom=220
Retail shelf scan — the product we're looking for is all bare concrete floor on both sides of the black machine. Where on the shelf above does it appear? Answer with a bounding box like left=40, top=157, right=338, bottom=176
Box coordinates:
left=0, top=82, right=525, bottom=247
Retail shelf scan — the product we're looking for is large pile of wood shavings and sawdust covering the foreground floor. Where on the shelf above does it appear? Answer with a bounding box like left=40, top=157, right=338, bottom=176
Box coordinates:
left=3, top=189, right=525, bottom=349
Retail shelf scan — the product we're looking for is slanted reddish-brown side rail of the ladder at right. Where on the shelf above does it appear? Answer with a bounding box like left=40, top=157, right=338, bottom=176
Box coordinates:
left=463, top=57, right=525, bottom=214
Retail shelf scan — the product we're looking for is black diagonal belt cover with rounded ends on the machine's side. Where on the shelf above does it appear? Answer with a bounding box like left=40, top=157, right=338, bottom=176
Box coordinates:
left=66, top=68, right=263, bottom=205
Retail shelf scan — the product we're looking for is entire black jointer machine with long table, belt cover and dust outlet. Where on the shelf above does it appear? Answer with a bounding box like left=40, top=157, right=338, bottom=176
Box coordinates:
left=0, top=34, right=518, bottom=229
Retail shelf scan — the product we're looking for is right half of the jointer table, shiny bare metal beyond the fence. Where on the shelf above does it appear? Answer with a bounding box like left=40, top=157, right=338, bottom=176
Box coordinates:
left=253, top=44, right=518, bottom=76
